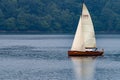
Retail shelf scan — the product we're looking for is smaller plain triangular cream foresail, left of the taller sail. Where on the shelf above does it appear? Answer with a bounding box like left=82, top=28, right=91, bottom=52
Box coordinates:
left=71, top=17, right=85, bottom=51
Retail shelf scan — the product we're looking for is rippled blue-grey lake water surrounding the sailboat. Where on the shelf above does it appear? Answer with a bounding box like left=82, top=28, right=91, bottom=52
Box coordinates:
left=0, top=35, right=120, bottom=80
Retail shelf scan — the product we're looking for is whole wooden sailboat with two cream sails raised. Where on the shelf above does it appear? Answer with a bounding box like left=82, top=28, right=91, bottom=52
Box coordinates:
left=68, top=2, right=104, bottom=56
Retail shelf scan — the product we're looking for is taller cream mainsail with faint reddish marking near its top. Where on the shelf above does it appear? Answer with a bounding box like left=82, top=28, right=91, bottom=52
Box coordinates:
left=81, top=3, right=96, bottom=48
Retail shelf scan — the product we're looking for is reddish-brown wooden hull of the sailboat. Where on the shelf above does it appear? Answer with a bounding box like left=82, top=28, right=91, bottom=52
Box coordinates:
left=68, top=51, right=104, bottom=56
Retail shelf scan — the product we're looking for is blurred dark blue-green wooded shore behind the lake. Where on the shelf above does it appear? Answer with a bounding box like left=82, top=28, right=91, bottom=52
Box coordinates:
left=0, top=0, right=120, bottom=33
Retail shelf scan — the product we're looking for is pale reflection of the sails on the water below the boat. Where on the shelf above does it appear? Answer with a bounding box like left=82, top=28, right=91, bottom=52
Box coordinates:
left=71, top=57, right=95, bottom=80
